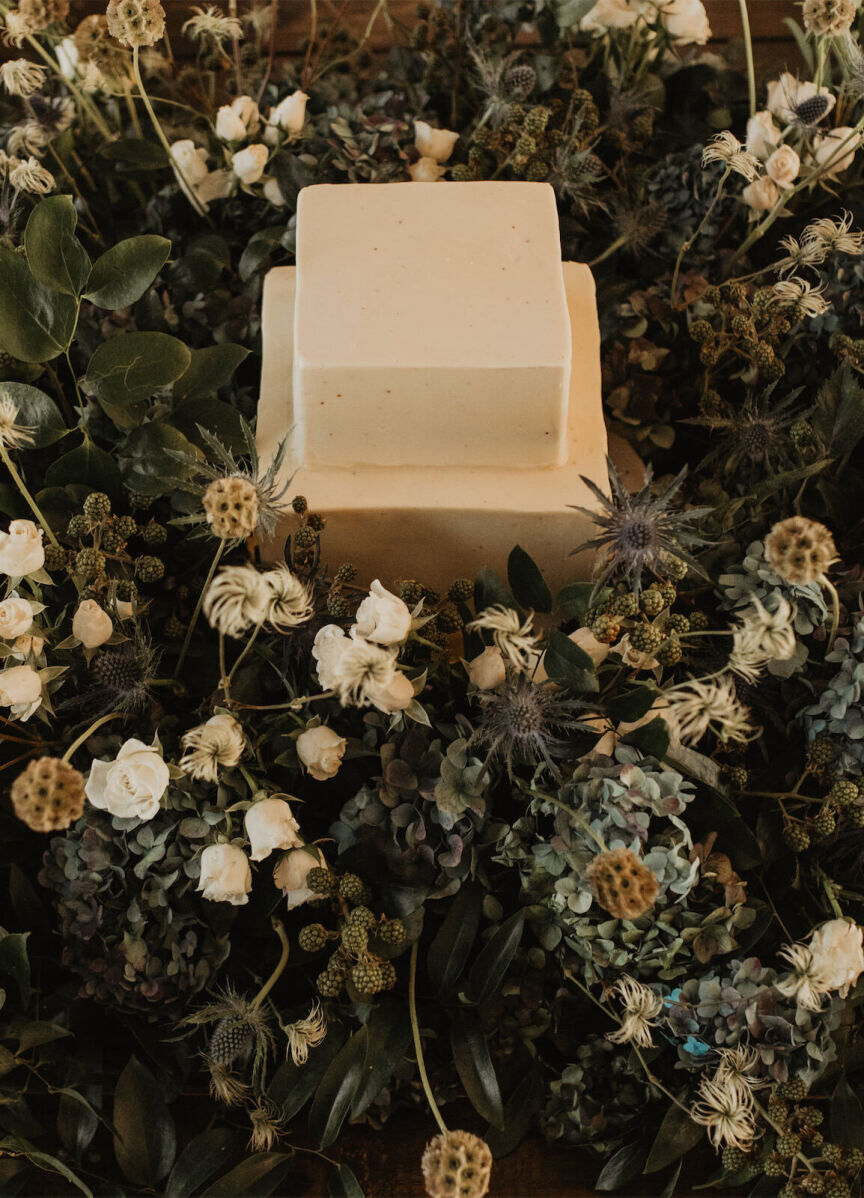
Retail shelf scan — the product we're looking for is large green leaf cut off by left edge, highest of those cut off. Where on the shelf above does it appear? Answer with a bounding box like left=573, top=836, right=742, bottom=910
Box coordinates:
left=0, top=246, right=77, bottom=362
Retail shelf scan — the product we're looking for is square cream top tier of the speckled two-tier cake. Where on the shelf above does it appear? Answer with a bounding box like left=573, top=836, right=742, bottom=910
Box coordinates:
left=292, top=182, right=572, bottom=468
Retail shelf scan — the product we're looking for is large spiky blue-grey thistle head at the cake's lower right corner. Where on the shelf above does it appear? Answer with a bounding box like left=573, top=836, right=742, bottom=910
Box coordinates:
left=568, top=460, right=712, bottom=595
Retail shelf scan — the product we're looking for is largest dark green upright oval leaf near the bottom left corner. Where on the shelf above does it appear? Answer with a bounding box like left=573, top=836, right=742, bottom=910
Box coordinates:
left=113, top=1055, right=177, bottom=1186
